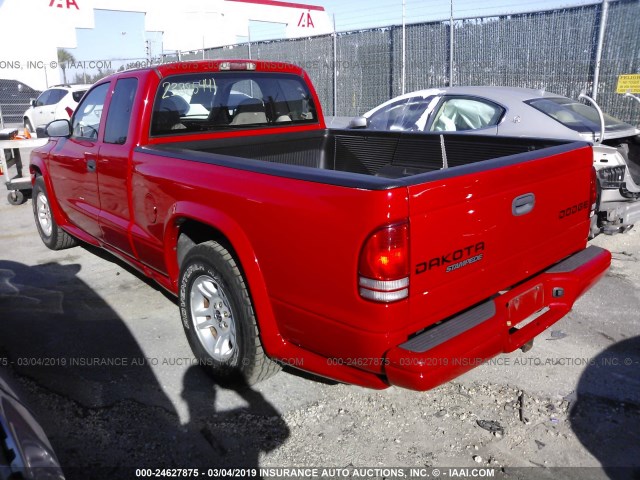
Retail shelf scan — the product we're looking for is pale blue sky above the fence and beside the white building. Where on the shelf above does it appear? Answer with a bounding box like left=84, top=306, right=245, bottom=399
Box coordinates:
left=69, top=0, right=597, bottom=64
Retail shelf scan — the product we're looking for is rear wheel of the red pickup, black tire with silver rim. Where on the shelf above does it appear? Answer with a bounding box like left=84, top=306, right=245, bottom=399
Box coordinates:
left=179, top=241, right=280, bottom=385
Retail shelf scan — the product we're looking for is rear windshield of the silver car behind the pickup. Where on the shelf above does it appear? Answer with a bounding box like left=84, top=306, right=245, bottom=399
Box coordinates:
left=526, top=97, right=633, bottom=133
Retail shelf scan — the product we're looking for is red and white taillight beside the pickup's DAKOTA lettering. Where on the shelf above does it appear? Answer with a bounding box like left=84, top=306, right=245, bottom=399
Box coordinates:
left=358, top=223, right=409, bottom=303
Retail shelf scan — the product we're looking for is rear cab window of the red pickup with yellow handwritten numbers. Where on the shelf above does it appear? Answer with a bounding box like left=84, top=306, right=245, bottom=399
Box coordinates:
left=151, top=72, right=317, bottom=135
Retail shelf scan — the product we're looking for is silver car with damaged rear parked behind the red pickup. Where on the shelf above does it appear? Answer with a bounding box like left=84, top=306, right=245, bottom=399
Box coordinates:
left=349, top=87, right=640, bottom=235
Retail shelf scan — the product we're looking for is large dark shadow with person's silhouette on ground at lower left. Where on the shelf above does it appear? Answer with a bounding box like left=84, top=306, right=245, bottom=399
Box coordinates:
left=0, top=260, right=289, bottom=479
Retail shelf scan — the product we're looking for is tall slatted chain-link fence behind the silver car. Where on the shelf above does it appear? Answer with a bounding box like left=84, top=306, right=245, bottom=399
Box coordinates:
left=0, top=0, right=640, bottom=124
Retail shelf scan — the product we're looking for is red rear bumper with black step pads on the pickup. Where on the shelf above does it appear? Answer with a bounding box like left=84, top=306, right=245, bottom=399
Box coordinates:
left=385, top=246, right=611, bottom=390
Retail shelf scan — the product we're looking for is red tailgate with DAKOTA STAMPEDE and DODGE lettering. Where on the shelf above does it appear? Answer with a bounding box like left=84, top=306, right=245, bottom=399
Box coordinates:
left=404, top=144, right=593, bottom=330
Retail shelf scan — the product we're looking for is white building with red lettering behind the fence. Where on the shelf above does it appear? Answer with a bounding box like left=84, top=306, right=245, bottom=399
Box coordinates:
left=0, top=0, right=333, bottom=90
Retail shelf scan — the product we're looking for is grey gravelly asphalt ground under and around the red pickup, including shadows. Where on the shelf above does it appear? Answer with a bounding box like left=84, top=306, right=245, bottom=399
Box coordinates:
left=0, top=158, right=640, bottom=479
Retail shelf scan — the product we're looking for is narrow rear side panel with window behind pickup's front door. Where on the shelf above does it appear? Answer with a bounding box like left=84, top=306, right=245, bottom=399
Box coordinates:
left=98, top=78, right=138, bottom=255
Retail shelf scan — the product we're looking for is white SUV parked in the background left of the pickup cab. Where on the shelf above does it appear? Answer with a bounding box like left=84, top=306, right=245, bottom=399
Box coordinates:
left=23, top=85, right=91, bottom=134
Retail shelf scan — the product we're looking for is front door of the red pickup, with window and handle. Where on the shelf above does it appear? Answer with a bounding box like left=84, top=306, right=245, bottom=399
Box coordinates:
left=49, top=82, right=110, bottom=242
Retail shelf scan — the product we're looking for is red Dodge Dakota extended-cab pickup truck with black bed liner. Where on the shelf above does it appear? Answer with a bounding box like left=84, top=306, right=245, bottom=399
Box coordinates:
left=30, top=60, right=611, bottom=390
